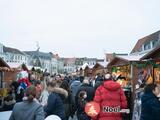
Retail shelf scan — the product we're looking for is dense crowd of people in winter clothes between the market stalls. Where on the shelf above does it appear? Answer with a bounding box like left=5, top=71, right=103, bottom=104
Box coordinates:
left=2, top=64, right=160, bottom=120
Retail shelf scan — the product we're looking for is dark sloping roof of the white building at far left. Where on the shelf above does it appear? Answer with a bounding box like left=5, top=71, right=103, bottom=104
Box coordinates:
left=3, top=46, right=24, bottom=55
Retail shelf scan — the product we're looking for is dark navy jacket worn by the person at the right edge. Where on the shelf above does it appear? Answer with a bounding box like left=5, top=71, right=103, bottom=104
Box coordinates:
left=140, top=92, right=160, bottom=120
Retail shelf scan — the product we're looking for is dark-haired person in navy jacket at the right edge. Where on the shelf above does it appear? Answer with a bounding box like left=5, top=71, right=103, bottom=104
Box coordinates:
left=140, top=84, right=160, bottom=120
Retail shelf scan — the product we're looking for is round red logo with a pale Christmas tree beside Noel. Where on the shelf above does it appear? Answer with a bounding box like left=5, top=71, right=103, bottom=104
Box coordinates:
left=85, top=102, right=100, bottom=117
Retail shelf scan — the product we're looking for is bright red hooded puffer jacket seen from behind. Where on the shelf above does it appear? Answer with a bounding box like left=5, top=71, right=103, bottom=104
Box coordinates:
left=94, top=80, right=127, bottom=120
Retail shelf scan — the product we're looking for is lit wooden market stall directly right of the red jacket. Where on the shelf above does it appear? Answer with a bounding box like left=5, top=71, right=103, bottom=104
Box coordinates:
left=107, top=55, right=144, bottom=117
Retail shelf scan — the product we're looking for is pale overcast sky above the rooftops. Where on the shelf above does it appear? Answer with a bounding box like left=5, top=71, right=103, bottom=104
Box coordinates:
left=0, top=0, right=160, bottom=58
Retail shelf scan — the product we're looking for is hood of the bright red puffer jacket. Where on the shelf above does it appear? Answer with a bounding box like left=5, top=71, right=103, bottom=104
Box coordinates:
left=103, top=80, right=121, bottom=91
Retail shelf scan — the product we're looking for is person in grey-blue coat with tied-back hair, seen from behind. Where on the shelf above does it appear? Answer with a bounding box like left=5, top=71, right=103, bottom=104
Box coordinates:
left=9, top=86, right=45, bottom=120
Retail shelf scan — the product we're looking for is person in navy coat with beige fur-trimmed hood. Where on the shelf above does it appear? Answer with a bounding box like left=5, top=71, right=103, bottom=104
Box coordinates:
left=44, top=80, right=68, bottom=120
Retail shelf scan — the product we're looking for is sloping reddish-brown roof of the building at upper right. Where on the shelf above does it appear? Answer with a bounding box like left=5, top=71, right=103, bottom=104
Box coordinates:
left=131, top=30, right=160, bottom=53
